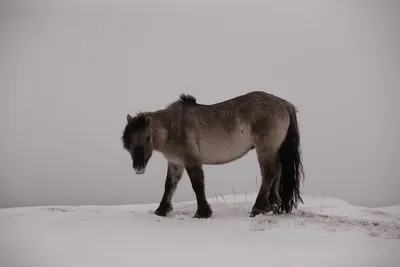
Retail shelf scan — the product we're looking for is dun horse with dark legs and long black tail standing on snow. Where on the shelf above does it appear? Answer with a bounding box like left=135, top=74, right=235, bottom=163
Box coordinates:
left=121, top=91, right=304, bottom=218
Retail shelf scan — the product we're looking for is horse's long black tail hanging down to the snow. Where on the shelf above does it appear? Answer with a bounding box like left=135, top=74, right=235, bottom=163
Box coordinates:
left=278, top=103, right=304, bottom=213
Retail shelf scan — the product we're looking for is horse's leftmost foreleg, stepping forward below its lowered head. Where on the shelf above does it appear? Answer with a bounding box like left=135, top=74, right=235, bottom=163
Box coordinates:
left=155, top=162, right=184, bottom=216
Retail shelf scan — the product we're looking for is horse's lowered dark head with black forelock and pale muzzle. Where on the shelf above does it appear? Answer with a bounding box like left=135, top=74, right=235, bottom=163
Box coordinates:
left=122, top=114, right=153, bottom=174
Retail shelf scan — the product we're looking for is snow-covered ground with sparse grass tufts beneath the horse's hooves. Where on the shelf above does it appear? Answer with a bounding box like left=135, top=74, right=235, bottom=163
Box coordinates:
left=0, top=195, right=400, bottom=267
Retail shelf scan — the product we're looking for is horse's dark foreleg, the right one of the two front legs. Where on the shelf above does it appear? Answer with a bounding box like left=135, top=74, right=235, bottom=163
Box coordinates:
left=186, top=166, right=212, bottom=218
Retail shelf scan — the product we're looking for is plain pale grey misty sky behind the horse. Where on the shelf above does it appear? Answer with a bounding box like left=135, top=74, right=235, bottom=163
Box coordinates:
left=0, top=0, right=400, bottom=207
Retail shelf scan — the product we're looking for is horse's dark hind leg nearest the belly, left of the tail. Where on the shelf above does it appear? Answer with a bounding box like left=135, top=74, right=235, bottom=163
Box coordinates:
left=250, top=149, right=280, bottom=217
